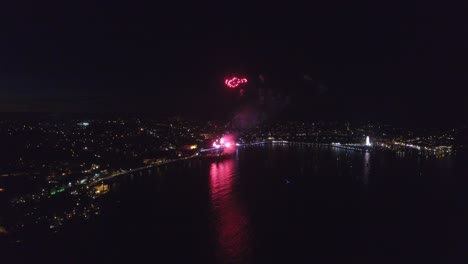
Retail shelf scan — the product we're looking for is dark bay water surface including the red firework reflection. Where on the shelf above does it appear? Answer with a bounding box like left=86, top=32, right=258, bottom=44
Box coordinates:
left=5, top=145, right=468, bottom=263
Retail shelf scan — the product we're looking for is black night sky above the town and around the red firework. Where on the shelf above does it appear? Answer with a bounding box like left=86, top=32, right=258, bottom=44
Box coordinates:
left=0, top=1, right=468, bottom=123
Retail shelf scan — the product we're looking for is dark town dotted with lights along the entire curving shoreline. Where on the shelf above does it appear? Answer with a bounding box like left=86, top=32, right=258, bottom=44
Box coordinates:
left=0, top=118, right=459, bottom=237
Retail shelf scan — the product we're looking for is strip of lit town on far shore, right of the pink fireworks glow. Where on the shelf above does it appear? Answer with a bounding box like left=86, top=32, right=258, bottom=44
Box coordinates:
left=240, top=121, right=460, bottom=153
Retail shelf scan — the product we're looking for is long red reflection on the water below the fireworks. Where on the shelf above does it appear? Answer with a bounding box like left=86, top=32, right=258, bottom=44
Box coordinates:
left=210, top=159, right=250, bottom=262
